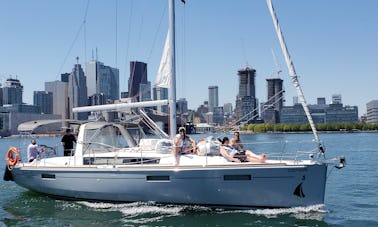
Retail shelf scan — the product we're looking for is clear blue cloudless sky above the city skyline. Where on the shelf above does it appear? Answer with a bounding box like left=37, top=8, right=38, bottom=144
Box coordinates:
left=0, top=0, right=378, bottom=115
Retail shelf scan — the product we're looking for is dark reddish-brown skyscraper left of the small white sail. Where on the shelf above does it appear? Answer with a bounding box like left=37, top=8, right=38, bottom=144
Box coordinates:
left=129, top=61, right=151, bottom=101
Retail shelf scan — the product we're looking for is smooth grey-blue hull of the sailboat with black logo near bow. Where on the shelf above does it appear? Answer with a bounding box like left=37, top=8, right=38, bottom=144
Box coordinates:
left=12, top=159, right=327, bottom=207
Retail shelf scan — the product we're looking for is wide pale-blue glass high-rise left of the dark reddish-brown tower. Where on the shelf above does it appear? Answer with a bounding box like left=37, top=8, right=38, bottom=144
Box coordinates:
left=85, top=60, right=119, bottom=104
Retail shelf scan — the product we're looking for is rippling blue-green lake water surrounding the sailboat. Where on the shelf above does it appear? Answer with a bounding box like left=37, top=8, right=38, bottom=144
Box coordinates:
left=0, top=133, right=378, bottom=226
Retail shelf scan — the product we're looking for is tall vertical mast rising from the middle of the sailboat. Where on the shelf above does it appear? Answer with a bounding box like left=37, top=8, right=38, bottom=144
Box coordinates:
left=168, top=0, right=177, bottom=138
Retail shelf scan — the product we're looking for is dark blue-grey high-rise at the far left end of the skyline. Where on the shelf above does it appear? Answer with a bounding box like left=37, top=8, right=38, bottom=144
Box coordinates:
left=3, top=78, right=24, bottom=105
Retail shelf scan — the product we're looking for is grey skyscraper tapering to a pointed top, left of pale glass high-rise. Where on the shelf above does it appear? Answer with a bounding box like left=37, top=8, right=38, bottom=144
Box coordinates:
left=68, top=58, right=88, bottom=120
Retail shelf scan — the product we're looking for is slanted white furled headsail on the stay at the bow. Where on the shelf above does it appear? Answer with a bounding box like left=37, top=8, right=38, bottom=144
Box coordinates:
left=266, top=0, right=323, bottom=147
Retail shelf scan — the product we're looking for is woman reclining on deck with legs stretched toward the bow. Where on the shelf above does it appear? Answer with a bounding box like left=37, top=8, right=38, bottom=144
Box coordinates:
left=220, top=137, right=266, bottom=163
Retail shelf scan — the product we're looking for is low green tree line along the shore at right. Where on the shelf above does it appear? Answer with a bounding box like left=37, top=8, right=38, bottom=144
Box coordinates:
left=240, top=122, right=378, bottom=133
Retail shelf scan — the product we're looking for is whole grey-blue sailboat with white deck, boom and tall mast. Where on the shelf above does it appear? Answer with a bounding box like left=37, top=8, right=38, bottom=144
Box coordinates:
left=6, top=0, right=345, bottom=209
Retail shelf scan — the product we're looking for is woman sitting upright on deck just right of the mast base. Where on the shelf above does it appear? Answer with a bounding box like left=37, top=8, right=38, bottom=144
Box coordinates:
left=175, top=127, right=196, bottom=164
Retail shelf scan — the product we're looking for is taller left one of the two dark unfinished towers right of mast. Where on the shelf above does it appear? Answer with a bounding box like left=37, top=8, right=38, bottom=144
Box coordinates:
left=235, top=67, right=258, bottom=122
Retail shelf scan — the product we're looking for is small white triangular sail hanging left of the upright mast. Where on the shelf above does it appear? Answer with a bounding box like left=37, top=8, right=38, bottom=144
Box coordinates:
left=156, top=30, right=172, bottom=88
